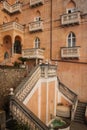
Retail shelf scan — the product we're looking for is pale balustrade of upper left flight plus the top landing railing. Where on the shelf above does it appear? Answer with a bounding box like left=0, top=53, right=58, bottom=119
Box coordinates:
left=14, top=64, right=57, bottom=101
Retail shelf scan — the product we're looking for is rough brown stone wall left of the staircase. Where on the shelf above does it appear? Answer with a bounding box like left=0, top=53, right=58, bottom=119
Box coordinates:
left=0, top=67, right=26, bottom=108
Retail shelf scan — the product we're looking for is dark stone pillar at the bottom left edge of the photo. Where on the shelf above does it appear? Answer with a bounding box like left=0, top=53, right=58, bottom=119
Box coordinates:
left=0, top=110, right=6, bottom=130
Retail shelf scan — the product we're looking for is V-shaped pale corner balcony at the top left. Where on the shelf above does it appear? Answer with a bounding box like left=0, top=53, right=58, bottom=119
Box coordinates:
left=3, top=1, right=21, bottom=14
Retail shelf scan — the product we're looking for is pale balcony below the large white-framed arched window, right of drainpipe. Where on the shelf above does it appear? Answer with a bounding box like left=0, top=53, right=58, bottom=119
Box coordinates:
left=61, top=46, right=80, bottom=58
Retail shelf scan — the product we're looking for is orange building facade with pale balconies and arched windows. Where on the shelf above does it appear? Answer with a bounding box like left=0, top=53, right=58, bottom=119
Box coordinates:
left=0, top=0, right=87, bottom=124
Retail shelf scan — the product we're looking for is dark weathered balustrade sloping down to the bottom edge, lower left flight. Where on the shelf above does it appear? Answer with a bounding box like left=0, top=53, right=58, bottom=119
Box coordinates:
left=10, top=96, right=49, bottom=130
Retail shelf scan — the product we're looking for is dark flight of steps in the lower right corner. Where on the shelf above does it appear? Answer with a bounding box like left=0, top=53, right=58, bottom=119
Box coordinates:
left=74, top=101, right=87, bottom=123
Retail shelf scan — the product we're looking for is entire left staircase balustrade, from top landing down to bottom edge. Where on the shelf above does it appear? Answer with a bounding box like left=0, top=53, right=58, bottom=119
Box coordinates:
left=10, top=64, right=57, bottom=130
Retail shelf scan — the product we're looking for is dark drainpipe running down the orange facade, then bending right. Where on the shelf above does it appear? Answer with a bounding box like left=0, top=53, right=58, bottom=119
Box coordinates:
left=50, top=0, right=87, bottom=64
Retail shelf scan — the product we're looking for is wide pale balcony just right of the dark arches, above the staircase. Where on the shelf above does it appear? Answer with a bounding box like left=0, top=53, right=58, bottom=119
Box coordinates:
left=22, top=48, right=44, bottom=59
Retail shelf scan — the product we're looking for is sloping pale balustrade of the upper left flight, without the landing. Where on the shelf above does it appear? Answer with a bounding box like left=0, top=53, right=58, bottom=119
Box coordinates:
left=15, top=66, right=41, bottom=101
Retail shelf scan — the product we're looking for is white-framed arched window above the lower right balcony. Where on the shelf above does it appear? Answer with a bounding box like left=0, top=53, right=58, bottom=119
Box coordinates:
left=68, top=32, right=76, bottom=47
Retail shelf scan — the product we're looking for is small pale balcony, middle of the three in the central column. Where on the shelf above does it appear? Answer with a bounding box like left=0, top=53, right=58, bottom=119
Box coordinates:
left=29, top=21, right=43, bottom=32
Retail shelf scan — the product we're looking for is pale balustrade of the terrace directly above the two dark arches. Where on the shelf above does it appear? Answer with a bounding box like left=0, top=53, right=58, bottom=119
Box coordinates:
left=0, top=22, right=24, bottom=32
